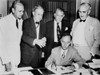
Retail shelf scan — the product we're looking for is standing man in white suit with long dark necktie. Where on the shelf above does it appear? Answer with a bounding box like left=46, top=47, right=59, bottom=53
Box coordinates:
left=0, top=1, right=24, bottom=71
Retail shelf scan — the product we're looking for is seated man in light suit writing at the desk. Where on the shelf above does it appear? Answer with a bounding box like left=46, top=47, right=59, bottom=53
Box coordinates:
left=45, top=33, right=85, bottom=67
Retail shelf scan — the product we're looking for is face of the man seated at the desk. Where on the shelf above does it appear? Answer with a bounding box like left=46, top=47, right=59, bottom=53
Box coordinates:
left=61, top=36, right=71, bottom=50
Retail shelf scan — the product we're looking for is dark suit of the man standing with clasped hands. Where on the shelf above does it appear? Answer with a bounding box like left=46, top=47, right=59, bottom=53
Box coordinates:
left=21, top=18, right=46, bottom=66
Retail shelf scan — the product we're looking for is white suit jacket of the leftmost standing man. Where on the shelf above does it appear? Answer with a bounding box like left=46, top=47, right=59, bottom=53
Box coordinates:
left=0, top=13, right=22, bottom=65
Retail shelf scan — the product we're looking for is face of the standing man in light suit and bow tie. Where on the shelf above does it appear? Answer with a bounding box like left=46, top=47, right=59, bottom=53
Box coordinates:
left=79, top=6, right=90, bottom=20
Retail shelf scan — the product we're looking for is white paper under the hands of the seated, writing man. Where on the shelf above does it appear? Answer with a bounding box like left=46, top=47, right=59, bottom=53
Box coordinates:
left=47, top=66, right=73, bottom=74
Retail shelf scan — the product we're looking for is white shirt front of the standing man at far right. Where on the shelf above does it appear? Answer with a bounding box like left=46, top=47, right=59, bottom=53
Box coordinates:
left=73, top=22, right=87, bottom=46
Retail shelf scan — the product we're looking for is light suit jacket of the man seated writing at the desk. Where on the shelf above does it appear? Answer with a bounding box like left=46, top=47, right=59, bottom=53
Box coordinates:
left=45, top=46, right=85, bottom=67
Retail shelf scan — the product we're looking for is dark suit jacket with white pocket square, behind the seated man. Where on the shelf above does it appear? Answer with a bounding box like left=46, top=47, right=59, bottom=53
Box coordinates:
left=45, top=20, right=70, bottom=58
